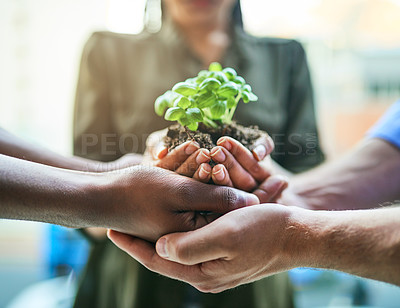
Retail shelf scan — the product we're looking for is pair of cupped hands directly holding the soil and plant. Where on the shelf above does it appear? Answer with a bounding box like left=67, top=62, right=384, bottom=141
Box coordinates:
left=145, top=130, right=288, bottom=203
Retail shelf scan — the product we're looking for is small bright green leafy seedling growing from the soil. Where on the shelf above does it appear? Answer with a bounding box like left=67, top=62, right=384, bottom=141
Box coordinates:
left=154, top=62, right=258, bottom=131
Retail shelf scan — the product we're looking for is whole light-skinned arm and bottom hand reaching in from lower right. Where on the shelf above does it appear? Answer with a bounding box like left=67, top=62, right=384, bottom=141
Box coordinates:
left=109, top=204, right=400, bottom=293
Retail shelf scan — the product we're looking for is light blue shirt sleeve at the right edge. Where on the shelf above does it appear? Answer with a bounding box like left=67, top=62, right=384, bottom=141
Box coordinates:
left=368, top=100, right=400, bottom=149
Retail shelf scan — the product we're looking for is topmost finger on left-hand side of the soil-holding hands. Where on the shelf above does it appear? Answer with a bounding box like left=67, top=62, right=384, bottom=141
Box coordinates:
left=156, top=141, right=200, bottom=171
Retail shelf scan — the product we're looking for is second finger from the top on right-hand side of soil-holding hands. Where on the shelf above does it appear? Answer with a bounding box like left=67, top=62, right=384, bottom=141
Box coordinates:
left=210, top=146, right=257, bottom=191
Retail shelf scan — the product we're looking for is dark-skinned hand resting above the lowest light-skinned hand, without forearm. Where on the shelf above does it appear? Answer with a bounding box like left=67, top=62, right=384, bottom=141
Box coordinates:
left=104, top=166, right=259, bottom=241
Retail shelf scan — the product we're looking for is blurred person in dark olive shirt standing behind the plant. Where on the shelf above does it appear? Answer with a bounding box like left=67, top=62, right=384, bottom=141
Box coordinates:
left=74, top=0, right=323, bottom=308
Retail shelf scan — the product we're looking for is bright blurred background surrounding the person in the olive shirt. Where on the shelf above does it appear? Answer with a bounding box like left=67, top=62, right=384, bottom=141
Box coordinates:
left=0, top=0, right=400, bottom=307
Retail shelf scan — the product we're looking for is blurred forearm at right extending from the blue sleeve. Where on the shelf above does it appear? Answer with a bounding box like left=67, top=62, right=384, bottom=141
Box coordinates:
left=279, top=139, right=400, bottom=210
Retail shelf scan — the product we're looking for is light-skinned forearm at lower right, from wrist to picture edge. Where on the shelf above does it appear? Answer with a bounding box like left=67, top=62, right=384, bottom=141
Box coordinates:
left=286, top=207, right=400, bottom=285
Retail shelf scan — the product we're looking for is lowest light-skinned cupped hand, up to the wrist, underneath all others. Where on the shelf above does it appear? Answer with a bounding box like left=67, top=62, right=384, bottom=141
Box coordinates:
left=108, top=204, right=296, bottom=293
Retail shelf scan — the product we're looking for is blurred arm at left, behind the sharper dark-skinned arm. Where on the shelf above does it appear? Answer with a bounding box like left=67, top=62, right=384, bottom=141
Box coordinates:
left=0, top=128, right=142, bottom=172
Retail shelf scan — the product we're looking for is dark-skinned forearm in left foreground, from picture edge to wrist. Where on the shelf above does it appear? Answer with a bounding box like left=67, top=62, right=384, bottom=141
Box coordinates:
left=0, top=155, right=112, bottom=228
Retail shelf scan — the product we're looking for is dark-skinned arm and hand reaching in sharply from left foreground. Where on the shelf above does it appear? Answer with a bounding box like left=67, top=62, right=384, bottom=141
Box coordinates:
left=0, top=154, right=258, bottom=240
